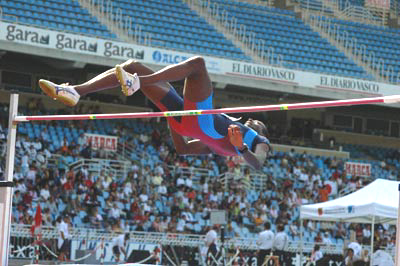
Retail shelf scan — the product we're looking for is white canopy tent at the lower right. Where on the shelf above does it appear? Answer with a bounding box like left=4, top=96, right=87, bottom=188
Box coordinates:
left=300, top=179, right=400, bottom=266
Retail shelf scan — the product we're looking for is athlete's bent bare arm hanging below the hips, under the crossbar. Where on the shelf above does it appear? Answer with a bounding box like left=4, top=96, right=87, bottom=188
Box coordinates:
left=169, top=127, right=211, bottom=155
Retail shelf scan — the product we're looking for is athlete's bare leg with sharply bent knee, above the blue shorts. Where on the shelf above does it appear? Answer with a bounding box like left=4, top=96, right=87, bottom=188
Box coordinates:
left=137, top=56, right=213, bottom=102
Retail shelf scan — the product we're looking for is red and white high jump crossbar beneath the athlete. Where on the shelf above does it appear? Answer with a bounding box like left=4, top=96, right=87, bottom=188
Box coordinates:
left=14, top=95, right=400, bottom=122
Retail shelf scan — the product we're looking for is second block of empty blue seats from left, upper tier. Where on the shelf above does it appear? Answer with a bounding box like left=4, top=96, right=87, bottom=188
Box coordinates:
left=80, top=0, right=251, bottom=61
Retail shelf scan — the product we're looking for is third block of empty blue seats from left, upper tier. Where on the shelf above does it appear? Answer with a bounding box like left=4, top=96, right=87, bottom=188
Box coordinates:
left=198, top=0, right=371, bottom=79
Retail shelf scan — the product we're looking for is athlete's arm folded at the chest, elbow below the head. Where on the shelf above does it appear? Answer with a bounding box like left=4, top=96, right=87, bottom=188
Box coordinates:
left=228, top=125, right=269, bottom=170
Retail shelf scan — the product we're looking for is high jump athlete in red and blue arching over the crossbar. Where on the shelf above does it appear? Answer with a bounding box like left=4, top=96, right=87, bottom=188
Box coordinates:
left=39, top=56, right=270, bottom=170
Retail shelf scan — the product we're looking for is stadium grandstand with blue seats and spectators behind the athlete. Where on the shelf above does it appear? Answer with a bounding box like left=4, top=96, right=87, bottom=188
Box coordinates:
left=0, top=0, right=400, bottom=266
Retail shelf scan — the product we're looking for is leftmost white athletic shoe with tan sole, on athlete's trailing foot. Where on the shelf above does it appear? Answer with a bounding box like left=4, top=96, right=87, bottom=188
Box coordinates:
left=39, top=79, right=81, bottom=107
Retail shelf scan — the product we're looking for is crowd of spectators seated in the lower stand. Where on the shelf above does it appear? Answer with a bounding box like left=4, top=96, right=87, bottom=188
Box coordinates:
left=0, top=99, right=397, bottom=251
